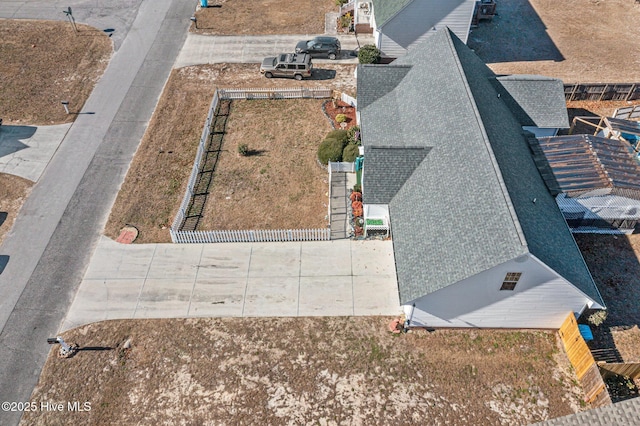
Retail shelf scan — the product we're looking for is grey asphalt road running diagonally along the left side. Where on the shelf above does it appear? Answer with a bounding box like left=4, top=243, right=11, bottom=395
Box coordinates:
left=0, top=0, right=196, bottom=425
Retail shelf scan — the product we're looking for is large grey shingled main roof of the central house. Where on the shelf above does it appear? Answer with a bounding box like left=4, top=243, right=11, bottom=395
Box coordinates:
left=358, top=29, right=604, bottom=306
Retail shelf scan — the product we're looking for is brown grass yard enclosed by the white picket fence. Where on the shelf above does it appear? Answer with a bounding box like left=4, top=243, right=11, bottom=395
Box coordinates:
left=198, top=99, right=331, bottom=230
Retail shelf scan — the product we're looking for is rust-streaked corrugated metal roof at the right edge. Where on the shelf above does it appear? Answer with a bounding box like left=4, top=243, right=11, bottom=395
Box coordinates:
left=530, top=135, right=640, bottom=200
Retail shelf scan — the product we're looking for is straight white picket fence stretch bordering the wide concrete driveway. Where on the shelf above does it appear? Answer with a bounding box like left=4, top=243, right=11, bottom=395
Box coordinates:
left=171, top=228, right=331, bottom=243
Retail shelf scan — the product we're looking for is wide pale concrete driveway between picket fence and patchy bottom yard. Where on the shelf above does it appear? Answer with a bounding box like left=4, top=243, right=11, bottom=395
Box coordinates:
left=62, top=237, right=401, bottom=330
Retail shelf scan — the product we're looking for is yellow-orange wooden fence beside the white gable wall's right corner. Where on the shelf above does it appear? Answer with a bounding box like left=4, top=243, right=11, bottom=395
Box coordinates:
left=558, top=312, right=611, bottom=406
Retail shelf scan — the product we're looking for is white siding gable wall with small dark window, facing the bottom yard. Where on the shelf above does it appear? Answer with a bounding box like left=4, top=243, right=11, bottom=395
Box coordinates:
left=403, top=254, right=599, bottom=328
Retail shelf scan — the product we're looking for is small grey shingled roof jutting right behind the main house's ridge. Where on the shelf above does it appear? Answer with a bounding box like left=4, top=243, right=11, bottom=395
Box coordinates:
left=496, top=75, right=569, bottom=129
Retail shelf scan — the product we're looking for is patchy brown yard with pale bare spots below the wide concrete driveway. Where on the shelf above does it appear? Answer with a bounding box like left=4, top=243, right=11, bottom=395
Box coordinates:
left=22, top=317, right=582, bottom=425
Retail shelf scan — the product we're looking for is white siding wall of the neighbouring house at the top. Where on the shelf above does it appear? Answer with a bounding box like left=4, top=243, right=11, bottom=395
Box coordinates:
left=377, top=0, right=475, bottom=57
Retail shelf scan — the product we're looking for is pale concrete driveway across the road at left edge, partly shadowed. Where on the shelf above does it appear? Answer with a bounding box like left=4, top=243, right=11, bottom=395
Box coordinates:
left=0, top=123, right=71, bottom=182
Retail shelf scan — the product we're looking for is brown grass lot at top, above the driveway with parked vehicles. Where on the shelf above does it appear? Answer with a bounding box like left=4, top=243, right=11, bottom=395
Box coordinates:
left=191, top=0, right=338, bottom=35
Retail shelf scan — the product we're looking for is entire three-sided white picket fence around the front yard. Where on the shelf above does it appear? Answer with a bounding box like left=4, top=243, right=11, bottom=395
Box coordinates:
left=169, top=87, right=336, bottom=243
